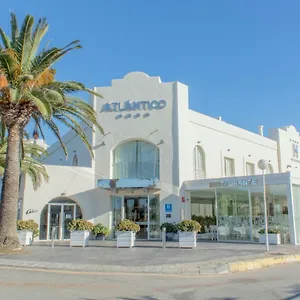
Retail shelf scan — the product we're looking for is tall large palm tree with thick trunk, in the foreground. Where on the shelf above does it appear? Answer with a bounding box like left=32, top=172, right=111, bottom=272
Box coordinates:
left=0, top=13, right=103, bottom=248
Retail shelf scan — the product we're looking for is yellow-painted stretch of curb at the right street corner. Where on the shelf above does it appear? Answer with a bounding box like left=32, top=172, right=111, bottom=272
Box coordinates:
left=216, top=254, right=300, bottom=274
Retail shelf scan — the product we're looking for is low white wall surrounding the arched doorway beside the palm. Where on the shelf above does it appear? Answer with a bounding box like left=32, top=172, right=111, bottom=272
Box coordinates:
left=22, top=165, right=108, bottom=224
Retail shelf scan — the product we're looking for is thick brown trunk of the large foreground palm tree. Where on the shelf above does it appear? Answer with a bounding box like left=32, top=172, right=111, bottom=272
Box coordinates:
left=0, top=123, right=20, bottom=249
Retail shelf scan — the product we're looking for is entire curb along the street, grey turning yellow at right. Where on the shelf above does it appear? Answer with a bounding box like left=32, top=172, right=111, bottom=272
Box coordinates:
left=0, top=254, right=300, bottom=276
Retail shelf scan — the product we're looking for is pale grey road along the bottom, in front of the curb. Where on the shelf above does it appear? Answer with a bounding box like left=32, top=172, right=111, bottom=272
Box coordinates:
left=0, top=264, right=300, bottom=300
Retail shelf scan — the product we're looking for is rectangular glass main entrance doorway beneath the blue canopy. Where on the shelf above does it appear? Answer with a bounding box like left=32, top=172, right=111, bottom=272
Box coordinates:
left=112, top=195, right=160, bottom=239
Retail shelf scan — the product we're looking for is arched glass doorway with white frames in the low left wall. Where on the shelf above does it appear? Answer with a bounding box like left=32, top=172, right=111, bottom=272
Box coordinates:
left=40, top=200, right=82, bottom=240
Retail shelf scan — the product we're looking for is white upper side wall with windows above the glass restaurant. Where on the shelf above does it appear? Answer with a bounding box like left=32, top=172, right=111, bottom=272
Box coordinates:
left=181, top=110, right=278, bottom=180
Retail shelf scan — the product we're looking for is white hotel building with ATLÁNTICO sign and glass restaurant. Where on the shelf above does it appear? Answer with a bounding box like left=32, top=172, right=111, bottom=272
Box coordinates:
left=19, top=72, right=300, bottom=244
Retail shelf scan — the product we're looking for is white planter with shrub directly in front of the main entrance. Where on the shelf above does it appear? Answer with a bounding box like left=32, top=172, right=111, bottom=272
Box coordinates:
left=116, top=219, right=140, bottom=248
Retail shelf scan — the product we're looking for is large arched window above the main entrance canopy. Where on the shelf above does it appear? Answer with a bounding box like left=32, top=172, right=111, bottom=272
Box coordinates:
left=113, top=140, right=159, bottom=179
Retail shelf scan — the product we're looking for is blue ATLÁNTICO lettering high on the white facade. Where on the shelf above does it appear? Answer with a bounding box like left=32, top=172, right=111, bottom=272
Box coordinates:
left=101, top=100, right=167, bottom=112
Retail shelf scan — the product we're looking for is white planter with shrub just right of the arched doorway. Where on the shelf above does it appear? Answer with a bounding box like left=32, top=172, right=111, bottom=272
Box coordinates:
left=68, top=219, right=93, bottom=247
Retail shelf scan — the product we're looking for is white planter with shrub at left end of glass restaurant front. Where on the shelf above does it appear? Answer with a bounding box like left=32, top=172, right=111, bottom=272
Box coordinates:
left=177, top=220, right=201, bottom=248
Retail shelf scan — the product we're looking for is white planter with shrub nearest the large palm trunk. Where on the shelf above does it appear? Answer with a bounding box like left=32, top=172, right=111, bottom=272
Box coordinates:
left=17, top=220, right=39, bottom=246
